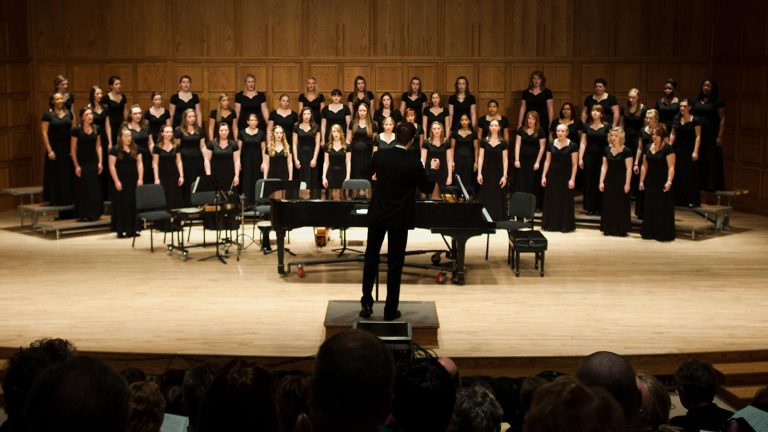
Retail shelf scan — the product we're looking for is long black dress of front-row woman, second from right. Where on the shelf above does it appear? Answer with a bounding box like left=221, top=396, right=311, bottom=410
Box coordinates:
left=600, top=146, right=633, bottom=237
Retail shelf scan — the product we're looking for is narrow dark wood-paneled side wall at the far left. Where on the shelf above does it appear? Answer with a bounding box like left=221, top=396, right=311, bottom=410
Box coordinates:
left=0, top=2, right=33, bottom=210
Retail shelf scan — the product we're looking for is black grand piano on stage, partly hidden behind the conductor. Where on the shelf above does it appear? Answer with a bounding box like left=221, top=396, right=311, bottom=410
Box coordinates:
left=271, top=189, right=495, bottom=285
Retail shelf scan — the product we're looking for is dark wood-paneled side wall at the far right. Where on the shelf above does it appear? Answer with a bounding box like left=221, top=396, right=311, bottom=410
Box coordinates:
left=714, top=0, right=768, bottom=215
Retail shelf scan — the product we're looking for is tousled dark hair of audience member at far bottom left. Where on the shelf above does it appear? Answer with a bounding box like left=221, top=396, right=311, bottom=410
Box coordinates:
left=3, top=339, right=75, bottom=430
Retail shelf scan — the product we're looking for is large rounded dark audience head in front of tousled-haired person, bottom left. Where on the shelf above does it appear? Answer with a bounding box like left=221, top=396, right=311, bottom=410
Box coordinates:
left=26, top=357, right=128, bottom=432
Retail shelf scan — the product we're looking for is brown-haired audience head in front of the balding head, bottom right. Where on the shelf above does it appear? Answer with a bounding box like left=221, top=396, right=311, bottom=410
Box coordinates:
left=523, top=376, right=634, bottom=432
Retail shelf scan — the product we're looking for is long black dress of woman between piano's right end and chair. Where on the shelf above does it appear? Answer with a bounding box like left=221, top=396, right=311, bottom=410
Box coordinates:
left=478, top=139, right=509, bottom=221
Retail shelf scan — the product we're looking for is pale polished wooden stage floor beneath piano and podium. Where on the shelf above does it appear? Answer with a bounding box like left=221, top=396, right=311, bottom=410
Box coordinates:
left=0, top=208, right=768, bottom=374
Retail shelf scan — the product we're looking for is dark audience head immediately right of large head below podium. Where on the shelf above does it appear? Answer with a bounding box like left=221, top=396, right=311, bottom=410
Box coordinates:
left=392, top=358, right=456, bottom=432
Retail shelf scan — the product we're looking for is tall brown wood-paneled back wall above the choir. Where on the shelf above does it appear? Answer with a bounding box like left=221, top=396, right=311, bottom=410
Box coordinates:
left=18, top=0, right=728, bottom=209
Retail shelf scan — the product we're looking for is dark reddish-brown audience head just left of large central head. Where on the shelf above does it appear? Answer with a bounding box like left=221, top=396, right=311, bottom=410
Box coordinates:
left=198, top=359, right=279, bottom=432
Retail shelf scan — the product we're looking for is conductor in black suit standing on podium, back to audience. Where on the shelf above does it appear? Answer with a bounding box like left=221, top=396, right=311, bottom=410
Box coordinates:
left=360, top=123, right=440, bottom=321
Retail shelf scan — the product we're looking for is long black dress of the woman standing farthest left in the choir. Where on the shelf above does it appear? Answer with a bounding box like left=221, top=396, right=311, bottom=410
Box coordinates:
left=42, top=111, right=75, bottom=205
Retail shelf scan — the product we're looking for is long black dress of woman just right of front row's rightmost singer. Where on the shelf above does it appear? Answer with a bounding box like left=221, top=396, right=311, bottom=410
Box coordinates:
left=673, top=116, right=701, bottom=207
